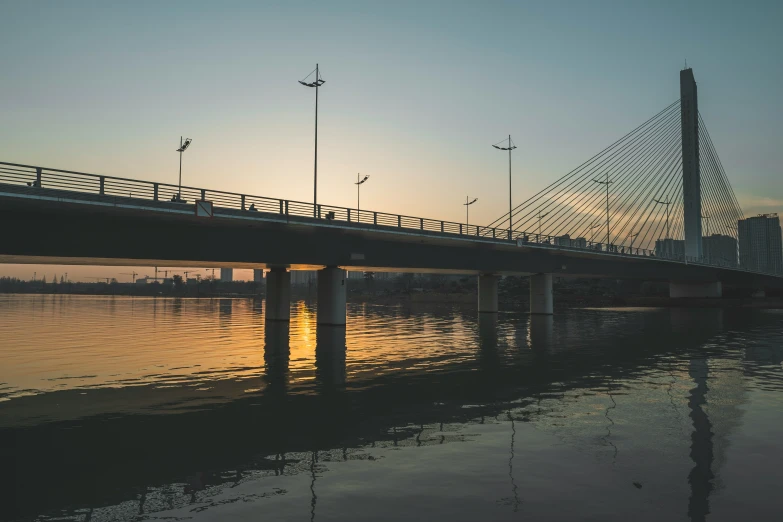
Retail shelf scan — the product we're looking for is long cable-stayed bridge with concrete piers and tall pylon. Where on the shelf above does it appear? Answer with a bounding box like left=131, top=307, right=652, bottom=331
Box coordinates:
left=0, top=69, right=783, bottom=325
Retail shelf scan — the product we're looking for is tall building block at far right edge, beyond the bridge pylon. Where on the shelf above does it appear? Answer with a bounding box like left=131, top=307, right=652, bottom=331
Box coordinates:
left=737, top=214, right=783, bottom=272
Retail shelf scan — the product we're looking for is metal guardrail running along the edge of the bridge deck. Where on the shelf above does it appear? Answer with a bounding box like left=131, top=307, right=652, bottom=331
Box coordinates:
left=0, top=162, right=782, bottom=276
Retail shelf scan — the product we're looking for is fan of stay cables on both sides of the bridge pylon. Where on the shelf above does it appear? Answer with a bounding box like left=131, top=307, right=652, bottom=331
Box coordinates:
left=489, top=91, right=744, bottom=264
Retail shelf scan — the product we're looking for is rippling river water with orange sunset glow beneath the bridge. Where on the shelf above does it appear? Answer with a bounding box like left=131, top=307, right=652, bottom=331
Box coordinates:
left=0, top=296, right=783, bottom=521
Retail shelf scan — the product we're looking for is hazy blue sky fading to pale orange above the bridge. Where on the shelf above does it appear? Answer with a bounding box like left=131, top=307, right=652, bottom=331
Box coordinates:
left=0, top=0, right=783, bottom=278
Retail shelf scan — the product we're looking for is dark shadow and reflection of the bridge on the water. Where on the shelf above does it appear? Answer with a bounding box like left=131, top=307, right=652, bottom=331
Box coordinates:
left=0, top=300, right=783, bottom=520
